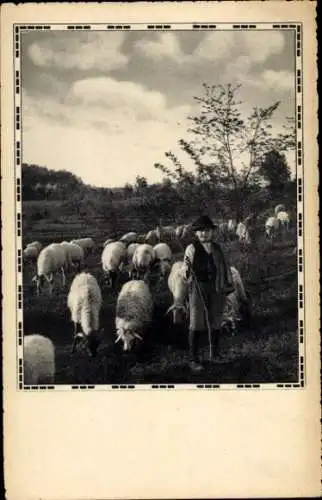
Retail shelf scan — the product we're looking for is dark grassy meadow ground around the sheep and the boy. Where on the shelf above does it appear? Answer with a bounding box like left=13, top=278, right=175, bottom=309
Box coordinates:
left=23, top=204, right=299, bottom=384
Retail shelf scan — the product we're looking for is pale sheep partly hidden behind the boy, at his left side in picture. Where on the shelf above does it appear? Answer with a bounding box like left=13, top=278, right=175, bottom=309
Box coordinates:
left=166, top=261, right=189, bottom=325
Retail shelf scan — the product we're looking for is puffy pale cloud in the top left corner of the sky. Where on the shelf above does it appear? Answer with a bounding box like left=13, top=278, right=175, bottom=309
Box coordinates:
left=28, top=32, right=128, bottom=71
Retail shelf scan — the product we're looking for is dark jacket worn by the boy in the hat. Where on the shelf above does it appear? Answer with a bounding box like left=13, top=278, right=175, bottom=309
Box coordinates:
left=192, top=240, right=234, bottom=295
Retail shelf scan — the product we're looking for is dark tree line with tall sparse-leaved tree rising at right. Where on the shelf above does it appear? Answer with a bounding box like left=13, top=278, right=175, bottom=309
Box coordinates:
left=22, top=84, right=295, bottom=230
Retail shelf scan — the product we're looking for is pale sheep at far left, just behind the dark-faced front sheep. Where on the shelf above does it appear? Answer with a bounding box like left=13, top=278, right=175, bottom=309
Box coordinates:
left=32, top=243, right=67, bottom=296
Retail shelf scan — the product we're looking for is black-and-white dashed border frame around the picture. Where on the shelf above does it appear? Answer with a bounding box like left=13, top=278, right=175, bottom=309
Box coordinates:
left=13, top=22, right=305, bottom=392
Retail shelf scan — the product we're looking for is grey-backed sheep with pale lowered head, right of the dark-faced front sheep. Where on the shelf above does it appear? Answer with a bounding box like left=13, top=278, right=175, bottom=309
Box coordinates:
left=115, top=280, right=153, bottom=351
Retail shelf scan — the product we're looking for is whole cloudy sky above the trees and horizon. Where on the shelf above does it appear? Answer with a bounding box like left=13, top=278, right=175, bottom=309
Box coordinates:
left=22, top=31, right=295, bottom=187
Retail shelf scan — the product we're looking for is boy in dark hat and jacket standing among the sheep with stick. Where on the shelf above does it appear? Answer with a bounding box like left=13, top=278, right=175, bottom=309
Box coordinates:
left=184, top=215, right=234, bottom=371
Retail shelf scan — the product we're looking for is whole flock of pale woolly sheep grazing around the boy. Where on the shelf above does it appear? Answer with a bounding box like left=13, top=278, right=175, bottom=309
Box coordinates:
left=23, top=205, right=289, bottom=384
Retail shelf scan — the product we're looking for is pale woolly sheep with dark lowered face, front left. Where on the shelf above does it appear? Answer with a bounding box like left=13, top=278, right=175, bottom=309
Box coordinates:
left=67, top=272, right=102, bottom=356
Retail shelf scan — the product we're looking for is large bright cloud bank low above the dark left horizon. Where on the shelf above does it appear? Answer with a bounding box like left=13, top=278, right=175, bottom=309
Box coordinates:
left=23, top=80, right=194, bottom=186
